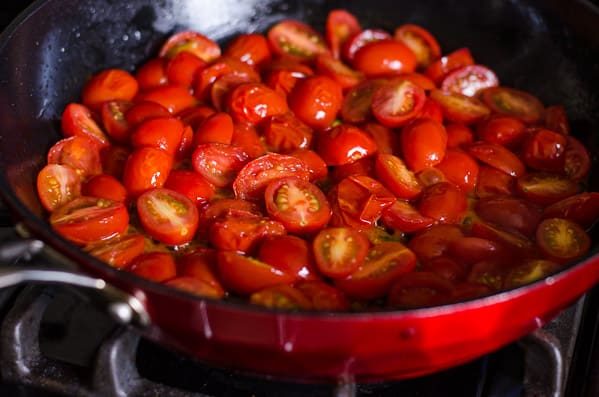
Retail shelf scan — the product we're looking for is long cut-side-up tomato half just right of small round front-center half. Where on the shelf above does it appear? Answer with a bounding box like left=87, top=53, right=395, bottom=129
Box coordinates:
left=334, top=242, right=416, bottom=300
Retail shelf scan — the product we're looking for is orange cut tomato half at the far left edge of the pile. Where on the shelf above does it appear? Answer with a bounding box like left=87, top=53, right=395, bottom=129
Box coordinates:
left=36, top=164, right=81, bottom=212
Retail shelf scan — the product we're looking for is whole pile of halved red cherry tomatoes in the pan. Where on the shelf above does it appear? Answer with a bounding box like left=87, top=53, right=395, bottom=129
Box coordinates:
left=37, top=9, right=599, bottom=310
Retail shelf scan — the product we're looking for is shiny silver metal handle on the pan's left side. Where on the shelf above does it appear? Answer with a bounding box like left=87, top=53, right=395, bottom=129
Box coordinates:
left=0, top=239, right=151, bottom=328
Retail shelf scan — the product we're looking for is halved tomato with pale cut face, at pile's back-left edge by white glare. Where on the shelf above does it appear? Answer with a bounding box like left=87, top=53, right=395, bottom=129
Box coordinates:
left=158, top=30, right=221, bottom=63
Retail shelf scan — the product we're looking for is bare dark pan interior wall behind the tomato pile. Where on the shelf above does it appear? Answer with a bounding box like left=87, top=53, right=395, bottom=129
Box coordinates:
left=0, top=0, right=599, bottom=278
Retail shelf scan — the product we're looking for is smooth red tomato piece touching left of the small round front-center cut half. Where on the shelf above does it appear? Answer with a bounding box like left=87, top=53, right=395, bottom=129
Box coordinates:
left=257, top=235, right=320, bottom=280
